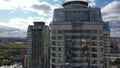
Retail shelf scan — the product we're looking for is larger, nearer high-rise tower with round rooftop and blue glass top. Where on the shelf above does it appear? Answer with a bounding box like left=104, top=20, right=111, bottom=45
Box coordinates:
left=50, top=0, right=110, bottom=68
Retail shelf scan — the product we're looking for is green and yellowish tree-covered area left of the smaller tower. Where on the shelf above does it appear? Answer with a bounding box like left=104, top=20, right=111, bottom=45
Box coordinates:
left=0, top=43, right=26, bottom=66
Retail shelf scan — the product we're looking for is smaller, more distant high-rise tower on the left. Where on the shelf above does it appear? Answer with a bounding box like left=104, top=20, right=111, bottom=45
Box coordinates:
left=27, top=22, right=50, bottom=68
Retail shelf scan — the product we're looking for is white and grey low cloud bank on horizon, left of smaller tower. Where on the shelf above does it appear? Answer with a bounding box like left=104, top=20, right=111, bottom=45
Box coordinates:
left=0, top=17, right=51, bottom=37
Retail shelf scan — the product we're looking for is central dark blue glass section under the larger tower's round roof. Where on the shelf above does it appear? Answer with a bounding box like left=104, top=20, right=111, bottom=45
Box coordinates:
left=65, top=10, right=89, bottom=21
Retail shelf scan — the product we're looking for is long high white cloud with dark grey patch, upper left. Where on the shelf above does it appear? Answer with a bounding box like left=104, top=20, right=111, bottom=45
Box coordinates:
left=0, top=0, right=55, bottom=16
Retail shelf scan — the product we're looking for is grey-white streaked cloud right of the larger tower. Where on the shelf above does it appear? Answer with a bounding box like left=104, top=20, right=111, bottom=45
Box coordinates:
left=101, top=1, right=120, bottom=37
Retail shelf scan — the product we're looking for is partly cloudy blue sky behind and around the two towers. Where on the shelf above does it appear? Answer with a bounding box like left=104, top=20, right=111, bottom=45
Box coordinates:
left=0, top=0, right=120, bottom=37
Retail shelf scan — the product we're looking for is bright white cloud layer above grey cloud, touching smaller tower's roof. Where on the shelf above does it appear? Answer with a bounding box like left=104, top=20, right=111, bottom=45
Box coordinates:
left=0, top=17, right=52, bottom=30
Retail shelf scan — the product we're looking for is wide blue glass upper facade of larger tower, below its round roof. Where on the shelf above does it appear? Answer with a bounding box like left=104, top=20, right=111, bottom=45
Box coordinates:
left=53, top=8, right=102, bottom=22
